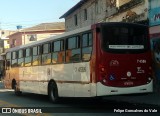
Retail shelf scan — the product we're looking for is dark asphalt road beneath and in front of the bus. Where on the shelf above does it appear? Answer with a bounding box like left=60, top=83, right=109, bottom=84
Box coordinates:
left=0, top=82, right=158, bottom=116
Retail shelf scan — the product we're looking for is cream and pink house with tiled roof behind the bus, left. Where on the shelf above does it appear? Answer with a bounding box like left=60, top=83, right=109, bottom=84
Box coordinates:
left=8, top=22, right=65, bottom=48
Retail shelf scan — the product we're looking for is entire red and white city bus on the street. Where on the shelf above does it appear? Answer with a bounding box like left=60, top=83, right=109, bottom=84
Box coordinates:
left=4, top=22, right=153, bottom=102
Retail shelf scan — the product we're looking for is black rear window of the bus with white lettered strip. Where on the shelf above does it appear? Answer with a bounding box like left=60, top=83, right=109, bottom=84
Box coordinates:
left=102, top=25, right=149, bottom=53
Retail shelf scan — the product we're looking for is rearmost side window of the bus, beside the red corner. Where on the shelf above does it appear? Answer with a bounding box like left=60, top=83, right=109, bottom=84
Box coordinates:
left=82, top=33, right=92, bottom=61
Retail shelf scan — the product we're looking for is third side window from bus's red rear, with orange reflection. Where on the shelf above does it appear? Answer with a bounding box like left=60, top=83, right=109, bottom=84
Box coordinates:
left=52, top=40, right=65, bottom=63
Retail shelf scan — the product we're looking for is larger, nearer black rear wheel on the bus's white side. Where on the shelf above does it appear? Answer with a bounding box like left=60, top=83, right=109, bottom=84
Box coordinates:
left=48, top=82, right=59, bottom=103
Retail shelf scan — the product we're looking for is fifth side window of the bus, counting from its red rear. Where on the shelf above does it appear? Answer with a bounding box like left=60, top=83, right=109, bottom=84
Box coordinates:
left=32, top=46, right=41, bottom=66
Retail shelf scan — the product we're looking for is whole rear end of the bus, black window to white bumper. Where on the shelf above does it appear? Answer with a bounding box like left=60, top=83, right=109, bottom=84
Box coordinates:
left=94, top=23, right=153, bottom=96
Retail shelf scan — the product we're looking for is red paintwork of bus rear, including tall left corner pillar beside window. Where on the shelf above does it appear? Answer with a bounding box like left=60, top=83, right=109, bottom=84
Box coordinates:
left=90, top=25, right=152, bottom=87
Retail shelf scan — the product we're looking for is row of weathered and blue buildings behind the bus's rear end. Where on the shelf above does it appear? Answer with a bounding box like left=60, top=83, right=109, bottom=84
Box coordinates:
left=60, top=0, right=160, bottom=88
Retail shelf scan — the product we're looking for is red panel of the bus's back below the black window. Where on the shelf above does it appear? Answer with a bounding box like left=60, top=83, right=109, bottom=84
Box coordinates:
left=96, top=52, right=151, bottom=87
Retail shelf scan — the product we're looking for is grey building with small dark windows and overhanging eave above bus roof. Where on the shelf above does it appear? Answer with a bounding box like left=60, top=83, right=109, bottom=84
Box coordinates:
left=60, top=0, right=116, bottom=31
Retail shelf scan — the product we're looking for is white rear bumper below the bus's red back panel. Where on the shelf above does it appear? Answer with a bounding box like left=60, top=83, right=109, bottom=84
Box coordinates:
left=97, top=80, right=153, bottom=96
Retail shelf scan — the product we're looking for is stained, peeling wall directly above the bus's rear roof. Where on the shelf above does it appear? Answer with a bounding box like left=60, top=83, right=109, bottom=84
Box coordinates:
left=106, top=0, right=148, bottom=22
